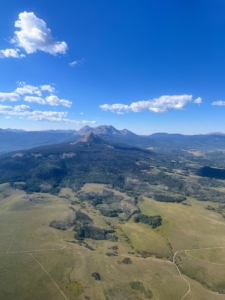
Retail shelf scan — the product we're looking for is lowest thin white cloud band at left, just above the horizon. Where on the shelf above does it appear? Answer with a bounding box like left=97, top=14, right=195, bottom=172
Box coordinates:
left=0, top=104, right=96, bottom=124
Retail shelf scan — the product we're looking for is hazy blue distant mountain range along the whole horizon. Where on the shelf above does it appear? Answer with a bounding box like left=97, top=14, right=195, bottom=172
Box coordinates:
left=0, top=125, right=225, bottom=154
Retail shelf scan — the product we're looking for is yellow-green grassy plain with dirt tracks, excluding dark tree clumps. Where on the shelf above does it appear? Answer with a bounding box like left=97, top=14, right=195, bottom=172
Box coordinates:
left=0, top=184, right=225, bottom=300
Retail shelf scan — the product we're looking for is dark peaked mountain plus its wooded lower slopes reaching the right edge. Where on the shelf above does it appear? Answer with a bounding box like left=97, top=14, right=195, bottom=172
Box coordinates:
left=0, top=132, right=225, bottom=202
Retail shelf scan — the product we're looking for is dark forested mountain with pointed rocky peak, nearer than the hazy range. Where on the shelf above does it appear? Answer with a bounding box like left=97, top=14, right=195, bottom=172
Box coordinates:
left=0, top=132, right=157, bottom=191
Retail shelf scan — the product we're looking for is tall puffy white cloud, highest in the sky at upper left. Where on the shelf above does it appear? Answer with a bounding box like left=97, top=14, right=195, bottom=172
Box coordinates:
left=11, top=11, right=68, bottom=55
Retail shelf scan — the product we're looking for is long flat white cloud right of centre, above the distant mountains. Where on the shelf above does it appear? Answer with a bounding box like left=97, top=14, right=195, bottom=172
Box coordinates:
left=100, top=95, right=193, bottom=114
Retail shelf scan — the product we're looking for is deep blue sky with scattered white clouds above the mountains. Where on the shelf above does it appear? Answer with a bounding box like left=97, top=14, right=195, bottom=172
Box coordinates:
left=0, top=0, right=225, bottom=134
